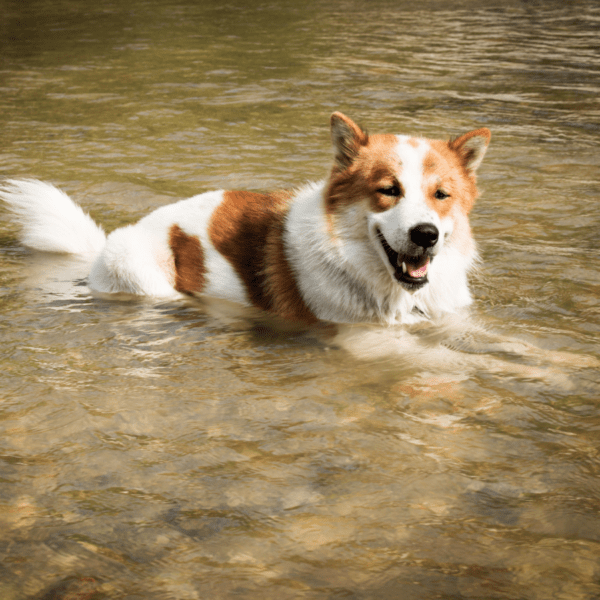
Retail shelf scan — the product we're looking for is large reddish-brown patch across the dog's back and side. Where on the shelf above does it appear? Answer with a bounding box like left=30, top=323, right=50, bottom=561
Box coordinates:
left=208, top=191, right=317, bottom=323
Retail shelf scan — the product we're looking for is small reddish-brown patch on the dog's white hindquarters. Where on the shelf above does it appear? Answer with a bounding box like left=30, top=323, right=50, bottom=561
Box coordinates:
left=169, top=225, right=206, bottom=295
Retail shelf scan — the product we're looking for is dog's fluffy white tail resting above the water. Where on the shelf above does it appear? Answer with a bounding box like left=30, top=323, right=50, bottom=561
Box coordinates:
left=0, top=179, right=106, bottom=258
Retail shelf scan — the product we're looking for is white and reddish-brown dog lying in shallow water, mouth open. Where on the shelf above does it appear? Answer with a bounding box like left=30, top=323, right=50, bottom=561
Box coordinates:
left=0, top=112, right=491, bottom=325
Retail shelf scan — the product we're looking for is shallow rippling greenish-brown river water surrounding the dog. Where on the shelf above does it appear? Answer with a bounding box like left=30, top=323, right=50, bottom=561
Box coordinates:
left=0, top=0, right=600, bottom=600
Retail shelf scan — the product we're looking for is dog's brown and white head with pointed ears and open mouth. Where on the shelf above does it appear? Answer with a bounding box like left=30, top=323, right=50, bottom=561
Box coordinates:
left=326, top=113, right=491, bottom=291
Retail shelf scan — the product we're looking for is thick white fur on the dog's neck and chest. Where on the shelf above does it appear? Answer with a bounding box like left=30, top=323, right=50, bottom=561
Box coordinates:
left=284, top=181, right=476, bottom=324
